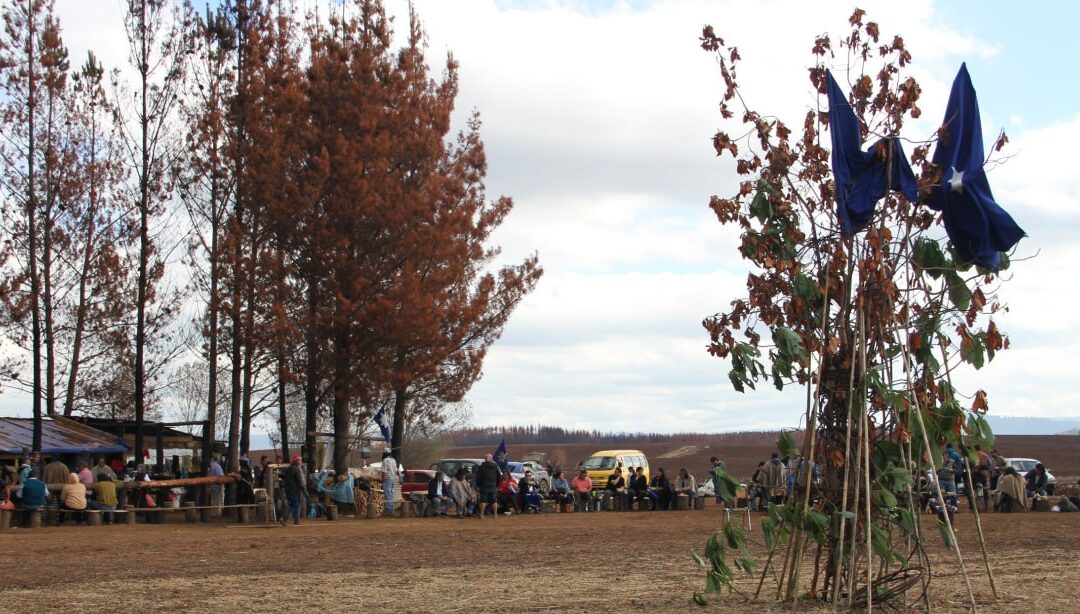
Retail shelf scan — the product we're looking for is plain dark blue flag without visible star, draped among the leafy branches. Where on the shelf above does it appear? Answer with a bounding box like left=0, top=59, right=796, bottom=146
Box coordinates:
left=825, top=70, right=919, bottom=236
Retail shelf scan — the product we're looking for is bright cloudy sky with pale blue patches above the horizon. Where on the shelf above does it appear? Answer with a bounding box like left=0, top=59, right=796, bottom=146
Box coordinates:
left=25, top=0, right=1080, bottom=432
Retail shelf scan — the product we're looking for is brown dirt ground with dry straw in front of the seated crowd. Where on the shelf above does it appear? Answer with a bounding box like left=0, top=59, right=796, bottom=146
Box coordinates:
left=0, top=505, right=1080, bottom=614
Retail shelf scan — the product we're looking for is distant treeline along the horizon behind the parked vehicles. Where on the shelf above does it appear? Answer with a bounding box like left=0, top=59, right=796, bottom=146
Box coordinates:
left=447, top=424, right=790, bottom=446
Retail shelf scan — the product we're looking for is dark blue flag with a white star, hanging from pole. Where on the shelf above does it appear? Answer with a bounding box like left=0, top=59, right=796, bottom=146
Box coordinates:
left=928, top=64, right=1026, bottom=271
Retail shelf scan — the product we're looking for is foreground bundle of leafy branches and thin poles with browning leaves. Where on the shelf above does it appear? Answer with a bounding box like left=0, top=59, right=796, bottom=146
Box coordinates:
left=696, top=10, right=1008, bottom=609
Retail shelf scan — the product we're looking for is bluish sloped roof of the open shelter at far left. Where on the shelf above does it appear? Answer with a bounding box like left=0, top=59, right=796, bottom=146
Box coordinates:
left=0, top=418, right=127, bottom=454
